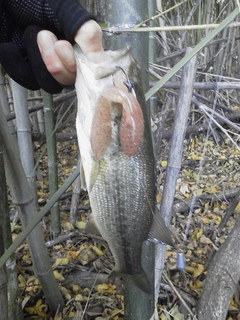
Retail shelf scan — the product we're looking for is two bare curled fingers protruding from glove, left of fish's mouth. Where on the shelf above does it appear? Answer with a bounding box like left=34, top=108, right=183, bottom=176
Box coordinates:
left=37, top=30, right=76, bottom=85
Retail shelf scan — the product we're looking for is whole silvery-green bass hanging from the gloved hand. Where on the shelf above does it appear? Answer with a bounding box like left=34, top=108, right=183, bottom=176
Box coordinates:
left=74, top=46, right=173, bottom=293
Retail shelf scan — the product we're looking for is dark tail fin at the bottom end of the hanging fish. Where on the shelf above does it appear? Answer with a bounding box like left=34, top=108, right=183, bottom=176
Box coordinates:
left=109, top=270, right=151, bottom=294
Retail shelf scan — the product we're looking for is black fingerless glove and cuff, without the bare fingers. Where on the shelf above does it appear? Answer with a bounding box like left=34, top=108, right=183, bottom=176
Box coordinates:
left=0, top=0, right=95, bottom=93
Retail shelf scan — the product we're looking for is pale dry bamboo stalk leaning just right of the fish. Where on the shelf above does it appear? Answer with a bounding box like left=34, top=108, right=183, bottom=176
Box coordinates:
left=153, top=47, right=197, bottom=296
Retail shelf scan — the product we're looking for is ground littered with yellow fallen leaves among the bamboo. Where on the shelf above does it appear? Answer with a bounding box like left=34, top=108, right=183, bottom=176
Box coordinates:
left=10, top=108, right=240, bottom=320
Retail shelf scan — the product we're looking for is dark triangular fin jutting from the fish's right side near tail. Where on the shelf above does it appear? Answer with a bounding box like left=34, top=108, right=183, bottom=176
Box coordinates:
left=148, top=214, right=175, bottom=247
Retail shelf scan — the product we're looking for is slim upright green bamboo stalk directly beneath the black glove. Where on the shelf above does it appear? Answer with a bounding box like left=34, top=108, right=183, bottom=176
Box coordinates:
left=42, top=90, right=61, bottom=233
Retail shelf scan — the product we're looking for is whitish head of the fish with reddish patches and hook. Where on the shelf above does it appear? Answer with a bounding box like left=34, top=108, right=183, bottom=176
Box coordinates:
left=75, top=47, right=144, bottom=161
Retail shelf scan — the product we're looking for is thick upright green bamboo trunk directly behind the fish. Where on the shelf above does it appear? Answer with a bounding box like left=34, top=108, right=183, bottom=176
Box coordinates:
left=105, top=0, right=155, bottom=320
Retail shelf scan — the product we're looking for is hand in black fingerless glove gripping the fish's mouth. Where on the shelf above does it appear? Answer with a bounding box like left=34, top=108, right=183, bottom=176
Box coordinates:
left=0, top=0, right=102, bottom=93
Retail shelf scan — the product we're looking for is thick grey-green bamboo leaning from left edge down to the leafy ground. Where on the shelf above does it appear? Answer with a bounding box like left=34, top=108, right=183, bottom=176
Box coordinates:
left=0, top=100, right=64, bottom=312
